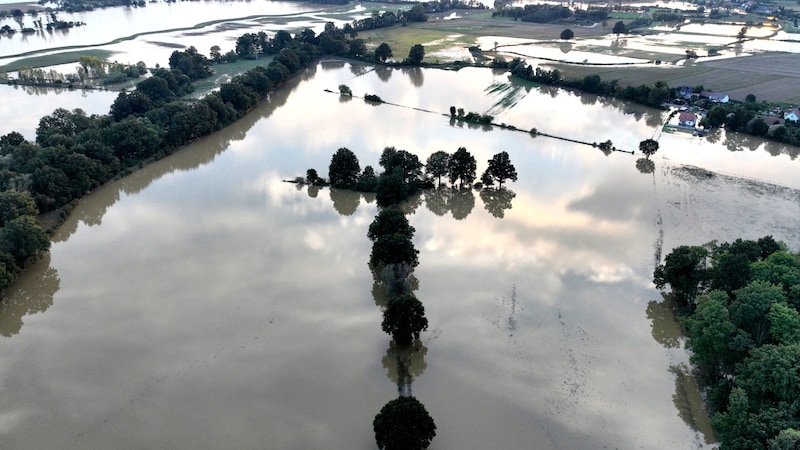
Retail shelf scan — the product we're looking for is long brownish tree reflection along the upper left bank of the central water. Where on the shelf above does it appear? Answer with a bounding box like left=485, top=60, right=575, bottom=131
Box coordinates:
left=51, top=66, right=316, bottom=242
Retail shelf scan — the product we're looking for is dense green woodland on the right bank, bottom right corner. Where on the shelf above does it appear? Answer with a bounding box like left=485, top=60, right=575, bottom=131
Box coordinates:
left=653, top=236, right=800, bottom=450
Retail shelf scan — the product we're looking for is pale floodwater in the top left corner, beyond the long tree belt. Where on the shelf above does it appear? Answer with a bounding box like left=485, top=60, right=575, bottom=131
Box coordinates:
left=0, top=0, right=346, bottom=67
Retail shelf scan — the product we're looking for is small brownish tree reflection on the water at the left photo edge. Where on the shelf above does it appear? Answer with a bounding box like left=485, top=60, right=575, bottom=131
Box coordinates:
left=0, top=253, right=61, bottom=337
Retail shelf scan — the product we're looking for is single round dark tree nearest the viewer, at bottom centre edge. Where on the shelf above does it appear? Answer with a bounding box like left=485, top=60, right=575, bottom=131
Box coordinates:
left=372, top=396, right=436, bottom=450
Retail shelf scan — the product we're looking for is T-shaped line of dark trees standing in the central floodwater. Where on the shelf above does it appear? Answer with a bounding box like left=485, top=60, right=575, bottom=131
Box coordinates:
left=318, top=143, right=517, bottom=450
